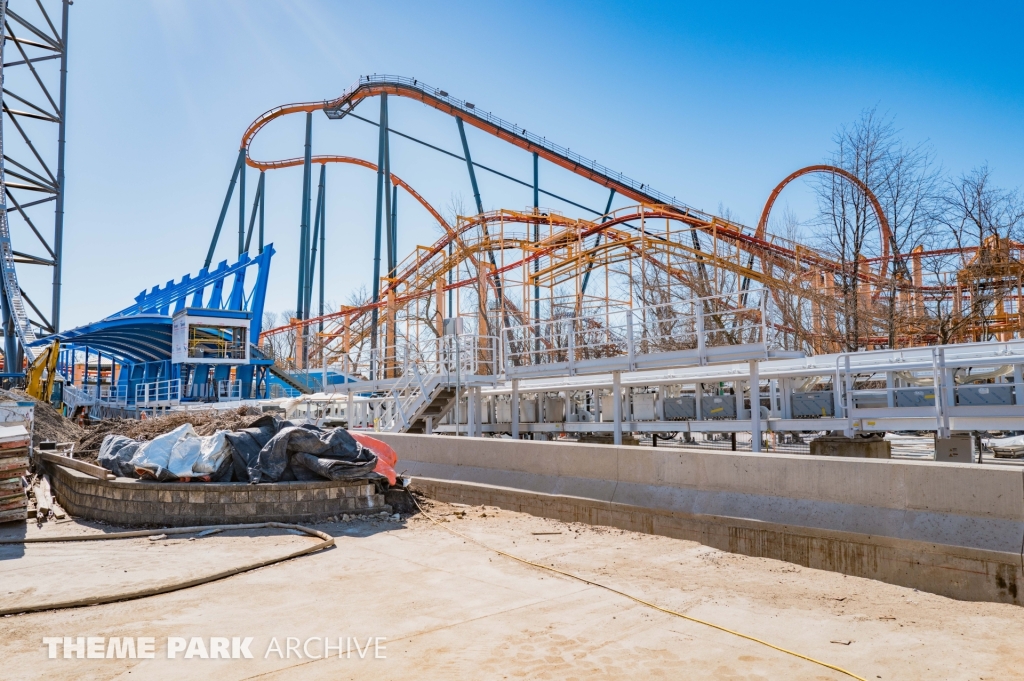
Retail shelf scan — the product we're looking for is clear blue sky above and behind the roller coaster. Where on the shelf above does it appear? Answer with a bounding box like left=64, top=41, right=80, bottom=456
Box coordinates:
left=34, top=0, right=1024, bottom=328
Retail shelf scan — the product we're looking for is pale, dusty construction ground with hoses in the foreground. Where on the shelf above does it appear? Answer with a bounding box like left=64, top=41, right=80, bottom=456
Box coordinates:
left=0, top=504, right=1024, bottom=681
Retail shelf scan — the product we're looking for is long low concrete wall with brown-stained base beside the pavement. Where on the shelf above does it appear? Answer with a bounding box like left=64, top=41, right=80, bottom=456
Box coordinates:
left=377, top=433, right=1024, bottom=604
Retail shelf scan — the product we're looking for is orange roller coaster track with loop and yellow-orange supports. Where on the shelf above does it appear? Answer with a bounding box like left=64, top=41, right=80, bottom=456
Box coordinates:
left=226, top=77, right=1024, bottom=378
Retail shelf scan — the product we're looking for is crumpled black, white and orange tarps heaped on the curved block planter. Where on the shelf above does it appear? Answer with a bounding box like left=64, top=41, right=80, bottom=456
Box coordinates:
left=98, top=415, right=397, bottom=484
